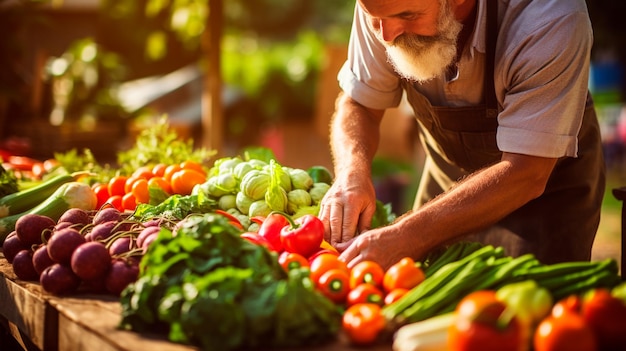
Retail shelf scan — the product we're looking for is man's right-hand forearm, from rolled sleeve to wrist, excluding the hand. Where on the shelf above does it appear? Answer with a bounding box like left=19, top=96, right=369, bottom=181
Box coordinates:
left=398, top=155, right=556, bottom=251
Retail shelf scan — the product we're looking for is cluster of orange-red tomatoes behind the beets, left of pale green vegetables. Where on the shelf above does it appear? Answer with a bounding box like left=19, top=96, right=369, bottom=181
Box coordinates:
left=92, top=161, right=207, bottom=211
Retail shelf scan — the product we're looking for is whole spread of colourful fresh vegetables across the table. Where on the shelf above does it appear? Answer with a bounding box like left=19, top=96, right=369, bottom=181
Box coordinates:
left=0, top=121, right=626, bottom=351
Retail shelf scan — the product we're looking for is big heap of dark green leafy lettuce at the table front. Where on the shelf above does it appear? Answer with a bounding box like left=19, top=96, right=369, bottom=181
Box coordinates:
left=120, top=214, right=341, bottom=351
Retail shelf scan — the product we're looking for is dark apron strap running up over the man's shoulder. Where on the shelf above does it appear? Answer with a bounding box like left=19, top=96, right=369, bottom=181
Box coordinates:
left=483, top=0, right=498, bottom=118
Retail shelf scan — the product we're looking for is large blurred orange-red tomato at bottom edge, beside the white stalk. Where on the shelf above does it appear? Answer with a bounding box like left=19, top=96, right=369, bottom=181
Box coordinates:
left=448, top=290, right=525, bottom=351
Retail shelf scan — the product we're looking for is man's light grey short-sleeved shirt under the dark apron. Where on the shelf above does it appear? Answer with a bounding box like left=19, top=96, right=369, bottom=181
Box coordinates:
left=338, top=0, right=593, bottom=158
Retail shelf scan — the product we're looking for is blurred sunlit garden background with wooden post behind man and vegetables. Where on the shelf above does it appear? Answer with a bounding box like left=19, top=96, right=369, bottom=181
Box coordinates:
left=0, top=0, right=626, bottom=258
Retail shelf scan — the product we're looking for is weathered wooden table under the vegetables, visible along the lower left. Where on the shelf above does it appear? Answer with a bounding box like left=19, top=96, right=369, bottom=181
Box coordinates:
left=0, top=251, right=391, bottom=351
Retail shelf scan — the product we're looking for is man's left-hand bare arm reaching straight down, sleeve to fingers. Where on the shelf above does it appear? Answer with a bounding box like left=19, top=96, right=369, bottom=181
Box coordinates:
left=320, top=94, right=384, bottom=244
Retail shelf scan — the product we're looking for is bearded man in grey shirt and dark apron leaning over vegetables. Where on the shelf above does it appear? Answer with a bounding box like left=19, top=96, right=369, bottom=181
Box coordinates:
left=320, top=0, right=605, bottom=267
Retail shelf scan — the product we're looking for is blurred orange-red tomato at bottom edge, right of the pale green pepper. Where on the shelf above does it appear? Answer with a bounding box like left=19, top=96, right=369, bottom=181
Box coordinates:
left=533, top=311, right=598, bottom=351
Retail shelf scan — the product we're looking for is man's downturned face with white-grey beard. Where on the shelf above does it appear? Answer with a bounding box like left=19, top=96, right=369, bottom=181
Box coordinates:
left=361, top=0, right=462, bottom=82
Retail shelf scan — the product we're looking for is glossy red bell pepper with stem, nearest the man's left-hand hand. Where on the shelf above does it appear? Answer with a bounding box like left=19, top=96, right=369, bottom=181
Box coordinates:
left=280, top=215, right=324, bottom=258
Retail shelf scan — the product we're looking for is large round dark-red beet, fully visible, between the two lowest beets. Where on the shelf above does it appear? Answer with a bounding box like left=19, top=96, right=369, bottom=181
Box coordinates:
left=70, top=241, right=111, bottom=280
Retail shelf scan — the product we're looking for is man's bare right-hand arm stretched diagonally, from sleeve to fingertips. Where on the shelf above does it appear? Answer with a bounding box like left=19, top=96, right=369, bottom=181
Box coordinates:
left=339, top=153, right=556, bottom=266
